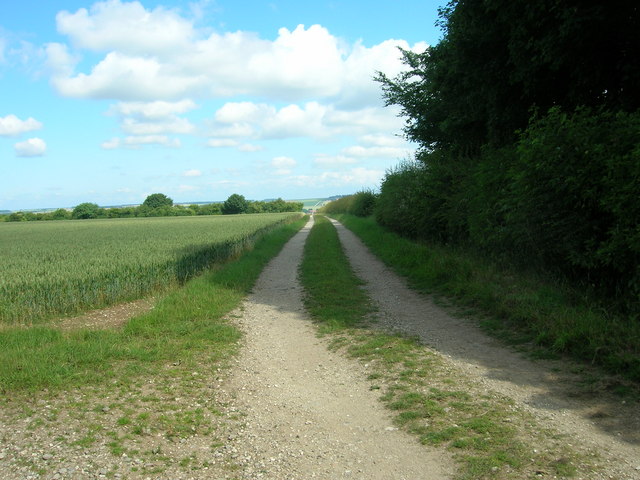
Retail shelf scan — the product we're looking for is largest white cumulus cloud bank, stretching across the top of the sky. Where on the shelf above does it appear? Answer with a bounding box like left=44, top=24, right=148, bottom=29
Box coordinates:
left=47, top=0, right=425, bottom=104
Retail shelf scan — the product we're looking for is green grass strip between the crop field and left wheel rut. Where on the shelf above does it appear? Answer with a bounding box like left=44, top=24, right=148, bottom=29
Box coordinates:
left=0, top=218, right=306, bottom=395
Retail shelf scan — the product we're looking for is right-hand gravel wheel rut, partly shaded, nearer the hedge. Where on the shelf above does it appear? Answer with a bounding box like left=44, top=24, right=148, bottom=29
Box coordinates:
left=334, top=221, right=640, bottom=480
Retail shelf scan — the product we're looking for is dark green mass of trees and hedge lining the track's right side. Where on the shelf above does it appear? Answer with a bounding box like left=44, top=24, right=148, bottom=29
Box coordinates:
left=375, top=0, right=640, bottom=316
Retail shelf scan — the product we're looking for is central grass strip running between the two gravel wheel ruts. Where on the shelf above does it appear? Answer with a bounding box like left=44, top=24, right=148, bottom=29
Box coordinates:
left=301, top=217, right=592, bottom=479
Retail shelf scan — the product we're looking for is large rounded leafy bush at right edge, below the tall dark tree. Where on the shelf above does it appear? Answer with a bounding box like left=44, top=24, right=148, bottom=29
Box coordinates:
left=507, top=108, right=640, bottom=302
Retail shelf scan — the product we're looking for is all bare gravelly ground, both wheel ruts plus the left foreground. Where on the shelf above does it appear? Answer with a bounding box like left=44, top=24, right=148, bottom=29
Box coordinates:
left=0, top=218, right=640, bottom=480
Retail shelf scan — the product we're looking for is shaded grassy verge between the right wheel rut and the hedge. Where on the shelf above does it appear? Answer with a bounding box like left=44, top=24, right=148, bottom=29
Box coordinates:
left=336, top=215, right=640, bottom=384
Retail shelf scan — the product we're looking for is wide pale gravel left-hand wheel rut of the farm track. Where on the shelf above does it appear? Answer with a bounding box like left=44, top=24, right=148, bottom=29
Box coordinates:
left=225, top=216, right=454, bottom=480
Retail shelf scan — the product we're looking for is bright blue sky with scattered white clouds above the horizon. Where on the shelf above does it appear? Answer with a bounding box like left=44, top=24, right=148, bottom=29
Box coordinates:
left=0, top=0, right=446, bottom=210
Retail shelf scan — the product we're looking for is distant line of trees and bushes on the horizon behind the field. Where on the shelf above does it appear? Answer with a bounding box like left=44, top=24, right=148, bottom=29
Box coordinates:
left=0, top=193, right=303, bottom=222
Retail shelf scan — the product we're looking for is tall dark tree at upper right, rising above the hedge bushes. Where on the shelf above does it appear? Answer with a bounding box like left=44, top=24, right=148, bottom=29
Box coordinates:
left=377, top=0, right=640, bottom=155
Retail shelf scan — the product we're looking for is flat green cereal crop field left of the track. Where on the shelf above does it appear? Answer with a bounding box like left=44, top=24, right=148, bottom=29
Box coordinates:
left=0, top=213, right=299, bottom=324
